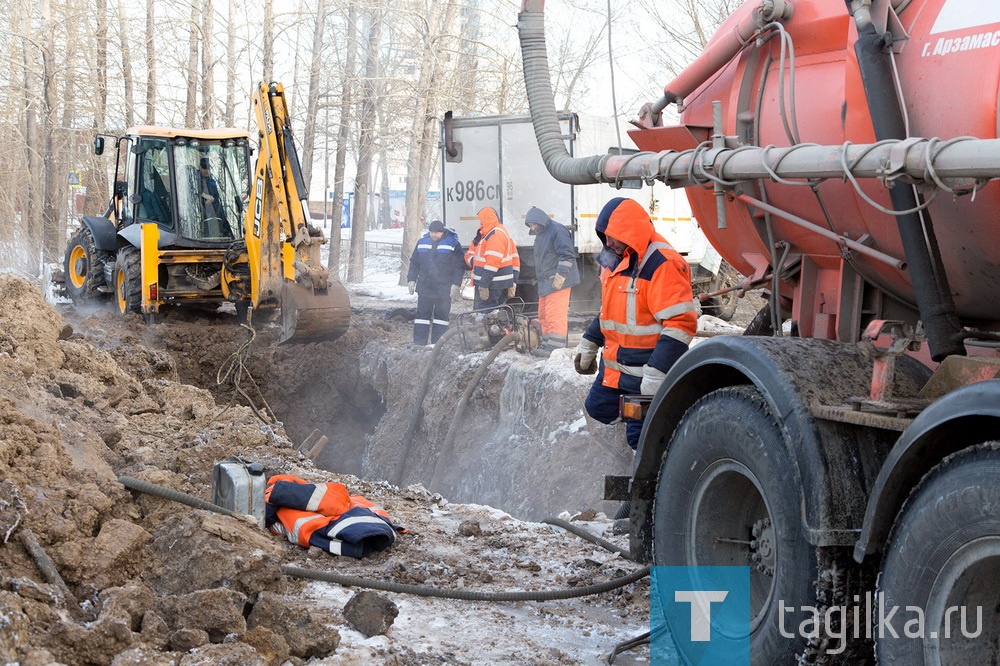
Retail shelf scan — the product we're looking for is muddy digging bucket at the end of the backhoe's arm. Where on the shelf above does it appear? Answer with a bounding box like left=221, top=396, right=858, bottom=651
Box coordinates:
left=278, top=282, right=351, bottom=344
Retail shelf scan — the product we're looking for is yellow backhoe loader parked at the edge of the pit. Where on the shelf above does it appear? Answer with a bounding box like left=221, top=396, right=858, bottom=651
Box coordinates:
left=65, top=83, right=351, bottom=342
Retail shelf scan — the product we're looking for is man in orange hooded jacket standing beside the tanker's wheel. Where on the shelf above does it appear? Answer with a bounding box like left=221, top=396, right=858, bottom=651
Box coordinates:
left=573, top=197, right=698, bottom=450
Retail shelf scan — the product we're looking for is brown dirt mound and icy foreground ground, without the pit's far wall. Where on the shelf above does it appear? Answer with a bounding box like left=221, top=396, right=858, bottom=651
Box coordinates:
left=0, top=275, right=648, bottom=665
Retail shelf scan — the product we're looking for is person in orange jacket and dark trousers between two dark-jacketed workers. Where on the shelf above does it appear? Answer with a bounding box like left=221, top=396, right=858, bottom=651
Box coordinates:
left=465, top=206, right=521, bottom=310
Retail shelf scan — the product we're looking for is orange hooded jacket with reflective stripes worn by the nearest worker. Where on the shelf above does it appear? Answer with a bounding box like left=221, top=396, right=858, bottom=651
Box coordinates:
left=584, top=199, right=698, bottom=393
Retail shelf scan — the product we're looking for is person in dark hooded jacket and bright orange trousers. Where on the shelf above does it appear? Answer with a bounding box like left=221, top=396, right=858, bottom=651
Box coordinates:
left=524, top=206, right=580, bottom=356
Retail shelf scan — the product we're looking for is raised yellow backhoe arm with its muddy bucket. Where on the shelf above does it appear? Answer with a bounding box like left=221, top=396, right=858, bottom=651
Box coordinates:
left=244, top=83, right=351, bottom=342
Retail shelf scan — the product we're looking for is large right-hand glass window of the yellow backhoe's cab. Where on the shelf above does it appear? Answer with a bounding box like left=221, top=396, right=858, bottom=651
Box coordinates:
left=174, top=139, right=249, bottom=242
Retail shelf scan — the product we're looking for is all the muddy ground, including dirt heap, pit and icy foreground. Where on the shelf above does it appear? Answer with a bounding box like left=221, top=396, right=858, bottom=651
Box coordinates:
left=0, top=275, right=756, bottom=666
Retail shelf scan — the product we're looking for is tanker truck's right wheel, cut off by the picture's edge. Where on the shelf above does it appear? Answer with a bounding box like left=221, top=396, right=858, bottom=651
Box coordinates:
left=872, top=441, right=1000, bottom=666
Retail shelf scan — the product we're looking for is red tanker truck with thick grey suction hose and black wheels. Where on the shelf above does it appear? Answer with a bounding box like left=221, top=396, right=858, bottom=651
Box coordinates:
left=519, top=0, right=1000, bottom=666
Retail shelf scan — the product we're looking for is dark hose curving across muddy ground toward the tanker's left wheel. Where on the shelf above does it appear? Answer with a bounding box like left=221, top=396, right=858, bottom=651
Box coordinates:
left=281, top=564, right=649, bottom=601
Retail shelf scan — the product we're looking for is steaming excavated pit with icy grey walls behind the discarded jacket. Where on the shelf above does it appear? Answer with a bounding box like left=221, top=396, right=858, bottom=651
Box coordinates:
left=143, top=306, right=632, bottom=520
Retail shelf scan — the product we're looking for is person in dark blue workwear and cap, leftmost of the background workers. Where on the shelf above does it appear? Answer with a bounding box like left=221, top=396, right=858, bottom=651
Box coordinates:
left=406, top=220, right=465, bottom=345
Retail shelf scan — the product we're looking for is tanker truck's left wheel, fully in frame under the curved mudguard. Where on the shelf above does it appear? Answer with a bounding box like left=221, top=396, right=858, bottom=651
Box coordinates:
left=653, top=386, right=817, bottom=666
